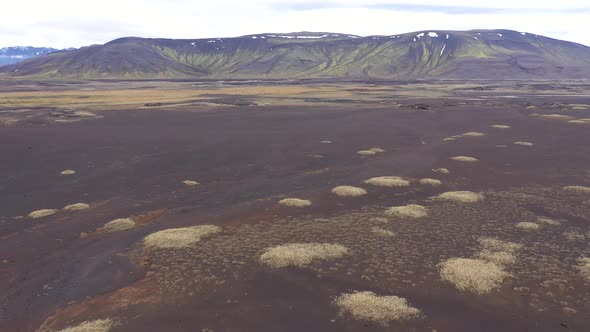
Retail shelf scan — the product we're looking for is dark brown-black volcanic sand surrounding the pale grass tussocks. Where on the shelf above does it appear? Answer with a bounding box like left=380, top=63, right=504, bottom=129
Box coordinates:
left=0, top=92, right=590, bottom=332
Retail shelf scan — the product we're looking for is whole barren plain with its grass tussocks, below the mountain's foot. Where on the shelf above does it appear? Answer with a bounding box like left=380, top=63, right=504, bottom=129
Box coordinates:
left=0, top=81, right=590, bottom=332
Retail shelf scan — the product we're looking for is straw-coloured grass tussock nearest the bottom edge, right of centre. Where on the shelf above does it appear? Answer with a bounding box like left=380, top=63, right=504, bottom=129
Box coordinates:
left=334, top=292, right=420, bottom=325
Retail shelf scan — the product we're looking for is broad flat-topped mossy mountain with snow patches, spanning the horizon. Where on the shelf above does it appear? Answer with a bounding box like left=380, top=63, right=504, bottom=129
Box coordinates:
left=0, top=30, right=590, bottom=79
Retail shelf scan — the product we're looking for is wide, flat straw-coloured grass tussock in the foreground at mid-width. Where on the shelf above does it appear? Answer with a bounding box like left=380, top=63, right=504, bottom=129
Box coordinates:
left=260, top=243, right=348, bottom=268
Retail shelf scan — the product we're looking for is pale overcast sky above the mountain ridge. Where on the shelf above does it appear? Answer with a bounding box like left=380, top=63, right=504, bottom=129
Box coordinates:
left=0, top=0, right=590, bottom=48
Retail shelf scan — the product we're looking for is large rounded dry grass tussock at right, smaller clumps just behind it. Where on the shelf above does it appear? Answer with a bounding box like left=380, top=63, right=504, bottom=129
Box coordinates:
left=440, top=258, right=508, bottom=294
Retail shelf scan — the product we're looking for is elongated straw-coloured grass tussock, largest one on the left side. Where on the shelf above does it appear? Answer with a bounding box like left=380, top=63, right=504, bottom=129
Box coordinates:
left=143, top=225, right=221, bottom=248
